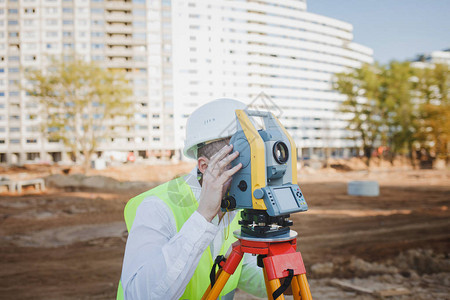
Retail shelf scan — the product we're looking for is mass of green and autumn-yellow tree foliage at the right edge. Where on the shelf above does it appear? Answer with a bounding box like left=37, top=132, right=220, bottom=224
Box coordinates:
left=333, top=61, right=450, bottom=164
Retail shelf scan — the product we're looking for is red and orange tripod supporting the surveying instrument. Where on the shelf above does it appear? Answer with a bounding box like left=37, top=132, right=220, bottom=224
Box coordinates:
left=202, top=230, right=312, bottom=300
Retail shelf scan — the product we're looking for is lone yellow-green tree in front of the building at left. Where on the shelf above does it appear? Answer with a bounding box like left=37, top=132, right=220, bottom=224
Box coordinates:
left=26, top=57, right=133, bottom=171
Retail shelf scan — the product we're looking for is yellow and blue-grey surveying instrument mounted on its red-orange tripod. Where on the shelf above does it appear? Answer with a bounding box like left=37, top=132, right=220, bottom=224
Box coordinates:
left=202, top=110, right=312, bottom=300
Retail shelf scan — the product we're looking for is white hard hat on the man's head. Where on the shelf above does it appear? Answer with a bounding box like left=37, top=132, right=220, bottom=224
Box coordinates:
left=183, top=98, right=246, bottom=159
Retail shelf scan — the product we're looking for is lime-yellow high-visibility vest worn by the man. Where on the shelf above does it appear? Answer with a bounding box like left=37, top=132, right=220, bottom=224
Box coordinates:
left=117, top=177, right=242, bottom=300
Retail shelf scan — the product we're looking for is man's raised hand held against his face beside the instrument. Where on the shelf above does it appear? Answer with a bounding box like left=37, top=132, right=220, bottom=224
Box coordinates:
left=197, top=145, right=242, bottom=222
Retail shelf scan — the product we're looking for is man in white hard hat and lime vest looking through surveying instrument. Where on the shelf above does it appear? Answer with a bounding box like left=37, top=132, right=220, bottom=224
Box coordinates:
left=117, top=99, right=266, bottom=299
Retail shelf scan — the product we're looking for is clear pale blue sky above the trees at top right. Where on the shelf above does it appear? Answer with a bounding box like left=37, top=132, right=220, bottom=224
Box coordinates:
left=307, top=0, right=450, bottom=63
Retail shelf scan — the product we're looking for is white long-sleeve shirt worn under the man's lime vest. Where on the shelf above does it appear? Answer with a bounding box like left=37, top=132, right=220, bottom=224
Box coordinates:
left=121, top=169, right=266, bottom=299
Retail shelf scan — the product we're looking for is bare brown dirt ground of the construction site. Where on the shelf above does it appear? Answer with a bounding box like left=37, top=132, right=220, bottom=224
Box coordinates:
left=0, top=164, right=450, bottom=299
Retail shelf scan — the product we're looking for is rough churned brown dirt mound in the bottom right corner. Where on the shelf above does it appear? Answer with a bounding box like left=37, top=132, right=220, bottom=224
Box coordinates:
left=310, top=249, right=450, bottom=299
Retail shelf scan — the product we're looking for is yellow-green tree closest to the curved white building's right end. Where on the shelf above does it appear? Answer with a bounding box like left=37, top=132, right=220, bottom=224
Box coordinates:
left=333, top=64, right=387, bottom=166
